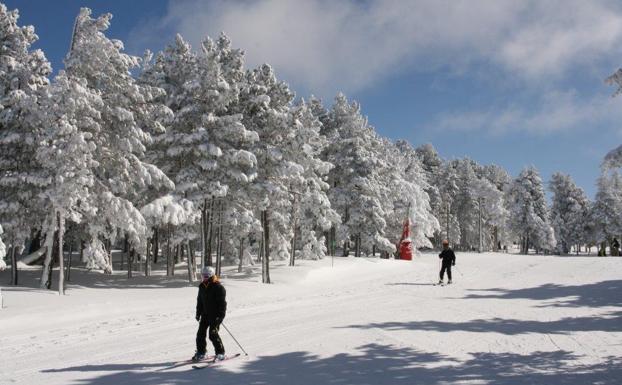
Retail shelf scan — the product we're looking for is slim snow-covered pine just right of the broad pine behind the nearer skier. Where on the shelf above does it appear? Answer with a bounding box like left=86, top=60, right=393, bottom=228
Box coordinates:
left=235, top=64, right=304, bottom=283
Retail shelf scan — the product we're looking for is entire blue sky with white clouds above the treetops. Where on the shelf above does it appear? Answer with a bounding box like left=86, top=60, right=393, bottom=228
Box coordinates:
left=6, top=0, right=622, bottom=197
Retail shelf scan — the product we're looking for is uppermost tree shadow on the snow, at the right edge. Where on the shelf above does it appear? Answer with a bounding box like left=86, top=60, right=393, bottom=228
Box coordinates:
left=465, top=280, right=622, bottom=307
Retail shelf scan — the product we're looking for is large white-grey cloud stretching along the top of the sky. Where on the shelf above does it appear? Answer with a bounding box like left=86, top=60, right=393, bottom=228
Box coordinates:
left=130, top=0, right=622, bottom=95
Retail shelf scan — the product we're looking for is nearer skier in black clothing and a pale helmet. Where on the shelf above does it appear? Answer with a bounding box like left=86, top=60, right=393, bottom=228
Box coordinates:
left=192, top=266, right=227, bottom=361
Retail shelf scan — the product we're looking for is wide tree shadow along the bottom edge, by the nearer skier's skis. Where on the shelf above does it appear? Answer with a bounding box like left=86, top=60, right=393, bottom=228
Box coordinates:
left=40, top=344, right=622, bottom=385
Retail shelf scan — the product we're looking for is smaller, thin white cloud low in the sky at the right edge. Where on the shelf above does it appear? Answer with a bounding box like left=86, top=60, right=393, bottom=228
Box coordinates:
left=426, top=91, right=622, bottom=135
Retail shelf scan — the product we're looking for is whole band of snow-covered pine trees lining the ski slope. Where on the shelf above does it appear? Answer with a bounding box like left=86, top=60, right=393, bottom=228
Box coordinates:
left=0, top=3, right=622, bottom=293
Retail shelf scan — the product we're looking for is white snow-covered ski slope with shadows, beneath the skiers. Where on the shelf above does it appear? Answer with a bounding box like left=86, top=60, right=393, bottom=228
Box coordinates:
left=0, top=253, right=622, bottom=385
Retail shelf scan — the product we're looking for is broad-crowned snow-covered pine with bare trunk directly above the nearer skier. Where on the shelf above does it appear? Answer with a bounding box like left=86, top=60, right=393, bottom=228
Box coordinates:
left=141, top=34, right=258, bottom=265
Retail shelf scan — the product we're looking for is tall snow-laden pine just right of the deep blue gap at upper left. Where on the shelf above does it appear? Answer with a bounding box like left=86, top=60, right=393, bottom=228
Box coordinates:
left=65, top=8, right=174, bottom=272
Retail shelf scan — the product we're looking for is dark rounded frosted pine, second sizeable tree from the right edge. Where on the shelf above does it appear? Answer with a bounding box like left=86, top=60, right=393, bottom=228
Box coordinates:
left=549, top=172, right=589, bottom=254
